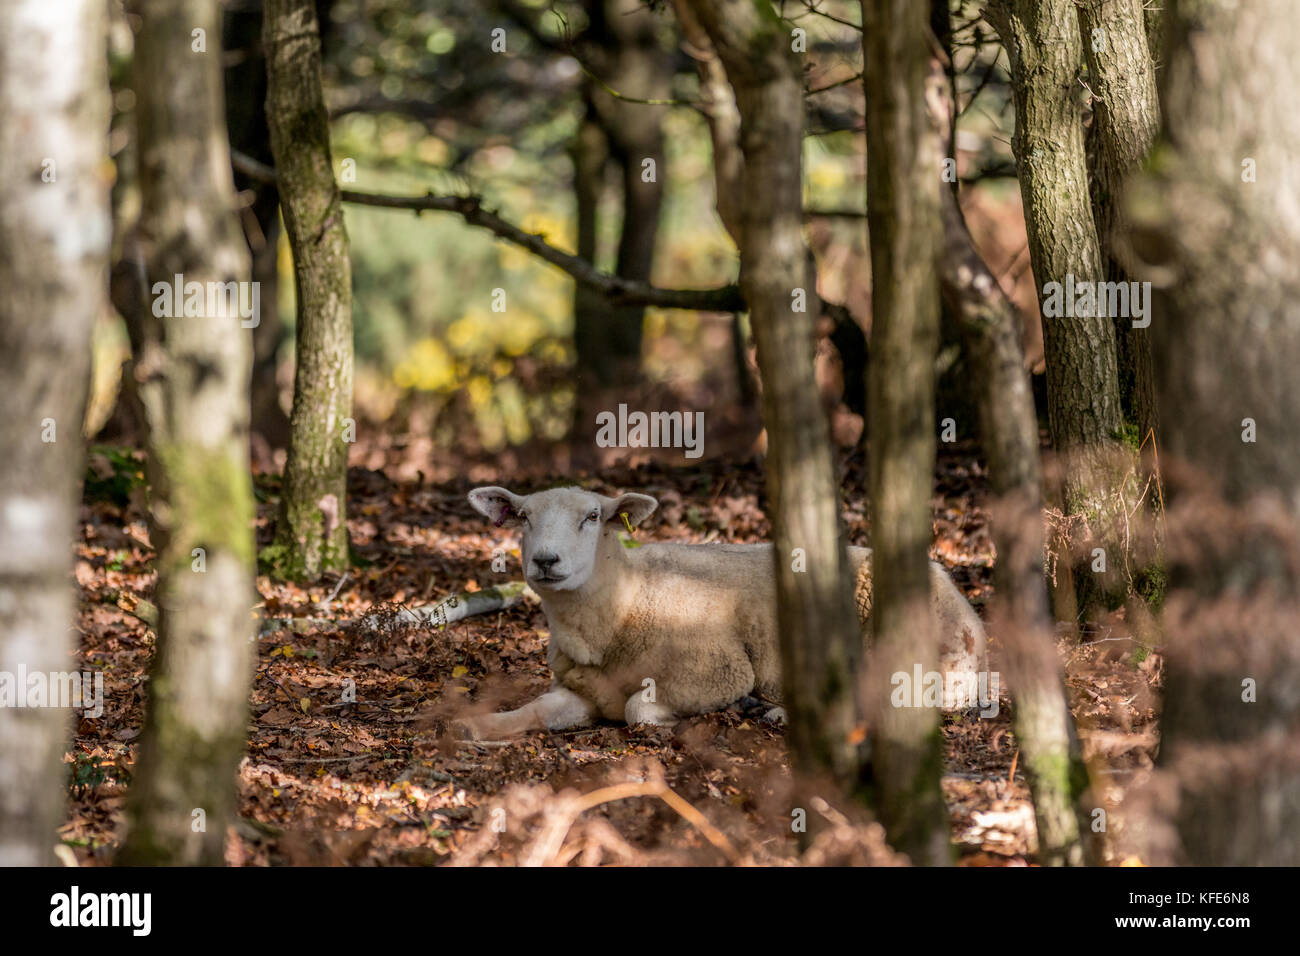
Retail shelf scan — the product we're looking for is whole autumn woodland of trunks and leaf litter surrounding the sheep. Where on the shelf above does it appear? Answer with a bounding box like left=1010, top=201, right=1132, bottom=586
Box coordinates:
left=0, top=0, right=1300, bottom=865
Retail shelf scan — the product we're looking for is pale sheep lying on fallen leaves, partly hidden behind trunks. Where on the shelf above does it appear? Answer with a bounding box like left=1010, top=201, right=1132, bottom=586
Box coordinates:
left=458, top=486, right=987, bottom=739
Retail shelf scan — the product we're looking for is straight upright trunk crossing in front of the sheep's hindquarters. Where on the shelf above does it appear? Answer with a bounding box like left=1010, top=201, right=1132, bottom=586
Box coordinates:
left=862, top=0, right=952, bottom=865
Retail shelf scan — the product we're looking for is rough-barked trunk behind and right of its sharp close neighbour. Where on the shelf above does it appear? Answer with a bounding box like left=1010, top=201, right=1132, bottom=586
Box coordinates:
left=1079, top=0, right=1160, bottom=441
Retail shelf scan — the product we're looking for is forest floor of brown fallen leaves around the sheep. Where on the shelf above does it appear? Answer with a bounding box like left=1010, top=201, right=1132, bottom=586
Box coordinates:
left=61, top=449, right=1162, bottom=865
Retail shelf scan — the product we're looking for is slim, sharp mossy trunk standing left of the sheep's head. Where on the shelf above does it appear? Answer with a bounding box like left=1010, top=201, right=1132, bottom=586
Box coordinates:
left=263, top=0, right=356, bottom=580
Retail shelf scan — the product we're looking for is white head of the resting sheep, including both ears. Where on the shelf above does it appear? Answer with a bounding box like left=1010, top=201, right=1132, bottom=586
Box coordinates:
left=469, top=486, right=659, bottom=591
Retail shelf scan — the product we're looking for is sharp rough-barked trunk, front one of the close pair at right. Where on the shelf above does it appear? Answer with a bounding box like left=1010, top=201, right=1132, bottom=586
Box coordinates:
left=985, top=0, right=1131, bottom=621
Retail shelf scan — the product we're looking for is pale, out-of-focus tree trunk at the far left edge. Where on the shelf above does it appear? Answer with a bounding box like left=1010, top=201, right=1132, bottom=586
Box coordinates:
left=0, top=0, right=112, bottom=866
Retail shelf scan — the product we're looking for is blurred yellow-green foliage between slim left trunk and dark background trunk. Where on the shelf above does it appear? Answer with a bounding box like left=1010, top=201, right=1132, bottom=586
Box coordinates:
left=335, top=115, right=595, bottom=450
